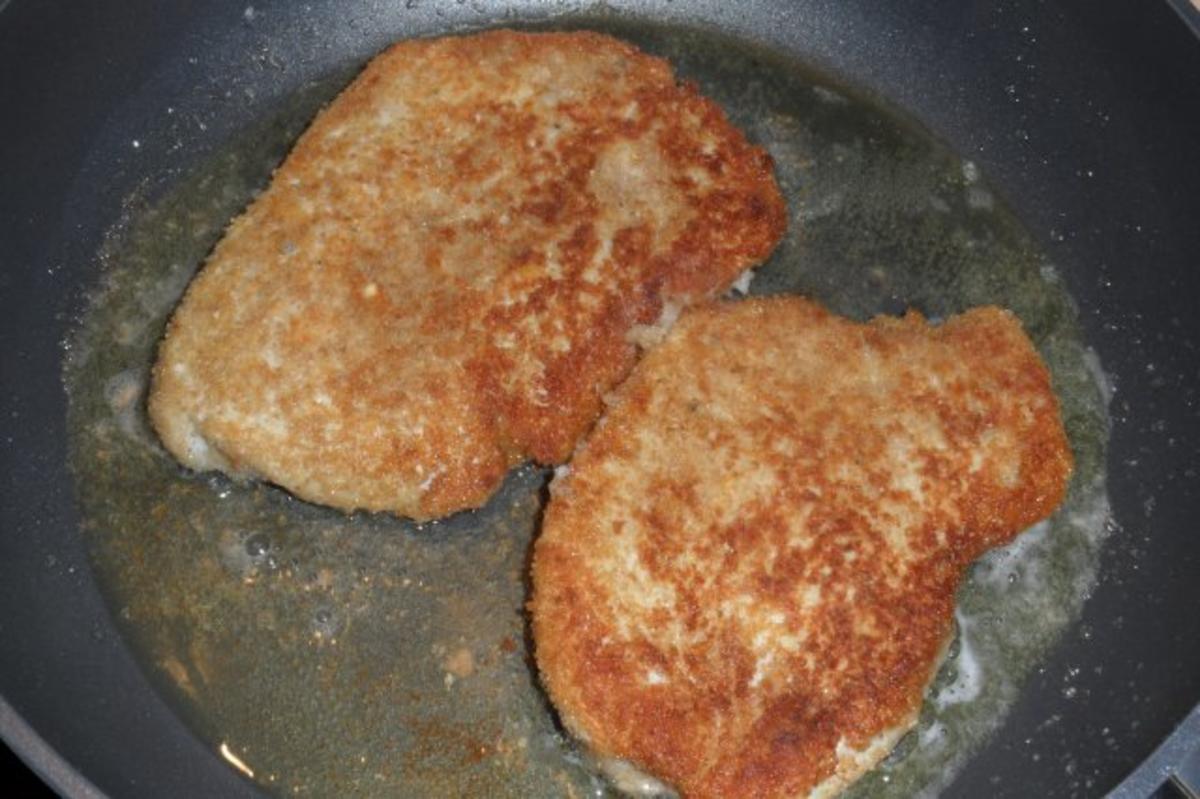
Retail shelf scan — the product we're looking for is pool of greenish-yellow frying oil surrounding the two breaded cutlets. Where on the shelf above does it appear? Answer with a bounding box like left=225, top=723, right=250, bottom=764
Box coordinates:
left=65, top=18, right=1109, bottom=797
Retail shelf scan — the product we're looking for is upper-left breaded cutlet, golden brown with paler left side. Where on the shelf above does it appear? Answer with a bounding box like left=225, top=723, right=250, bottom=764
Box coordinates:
left=150, top=31, right=785, bottom=518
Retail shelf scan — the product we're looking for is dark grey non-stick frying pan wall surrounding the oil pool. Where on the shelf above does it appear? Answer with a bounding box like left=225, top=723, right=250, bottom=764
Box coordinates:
left=0, top=0, right=1200, bottom=797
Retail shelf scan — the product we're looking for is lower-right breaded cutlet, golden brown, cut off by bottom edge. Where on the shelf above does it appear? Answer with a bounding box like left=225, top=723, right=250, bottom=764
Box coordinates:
left=530, top=298, right=1072, bottom=798
